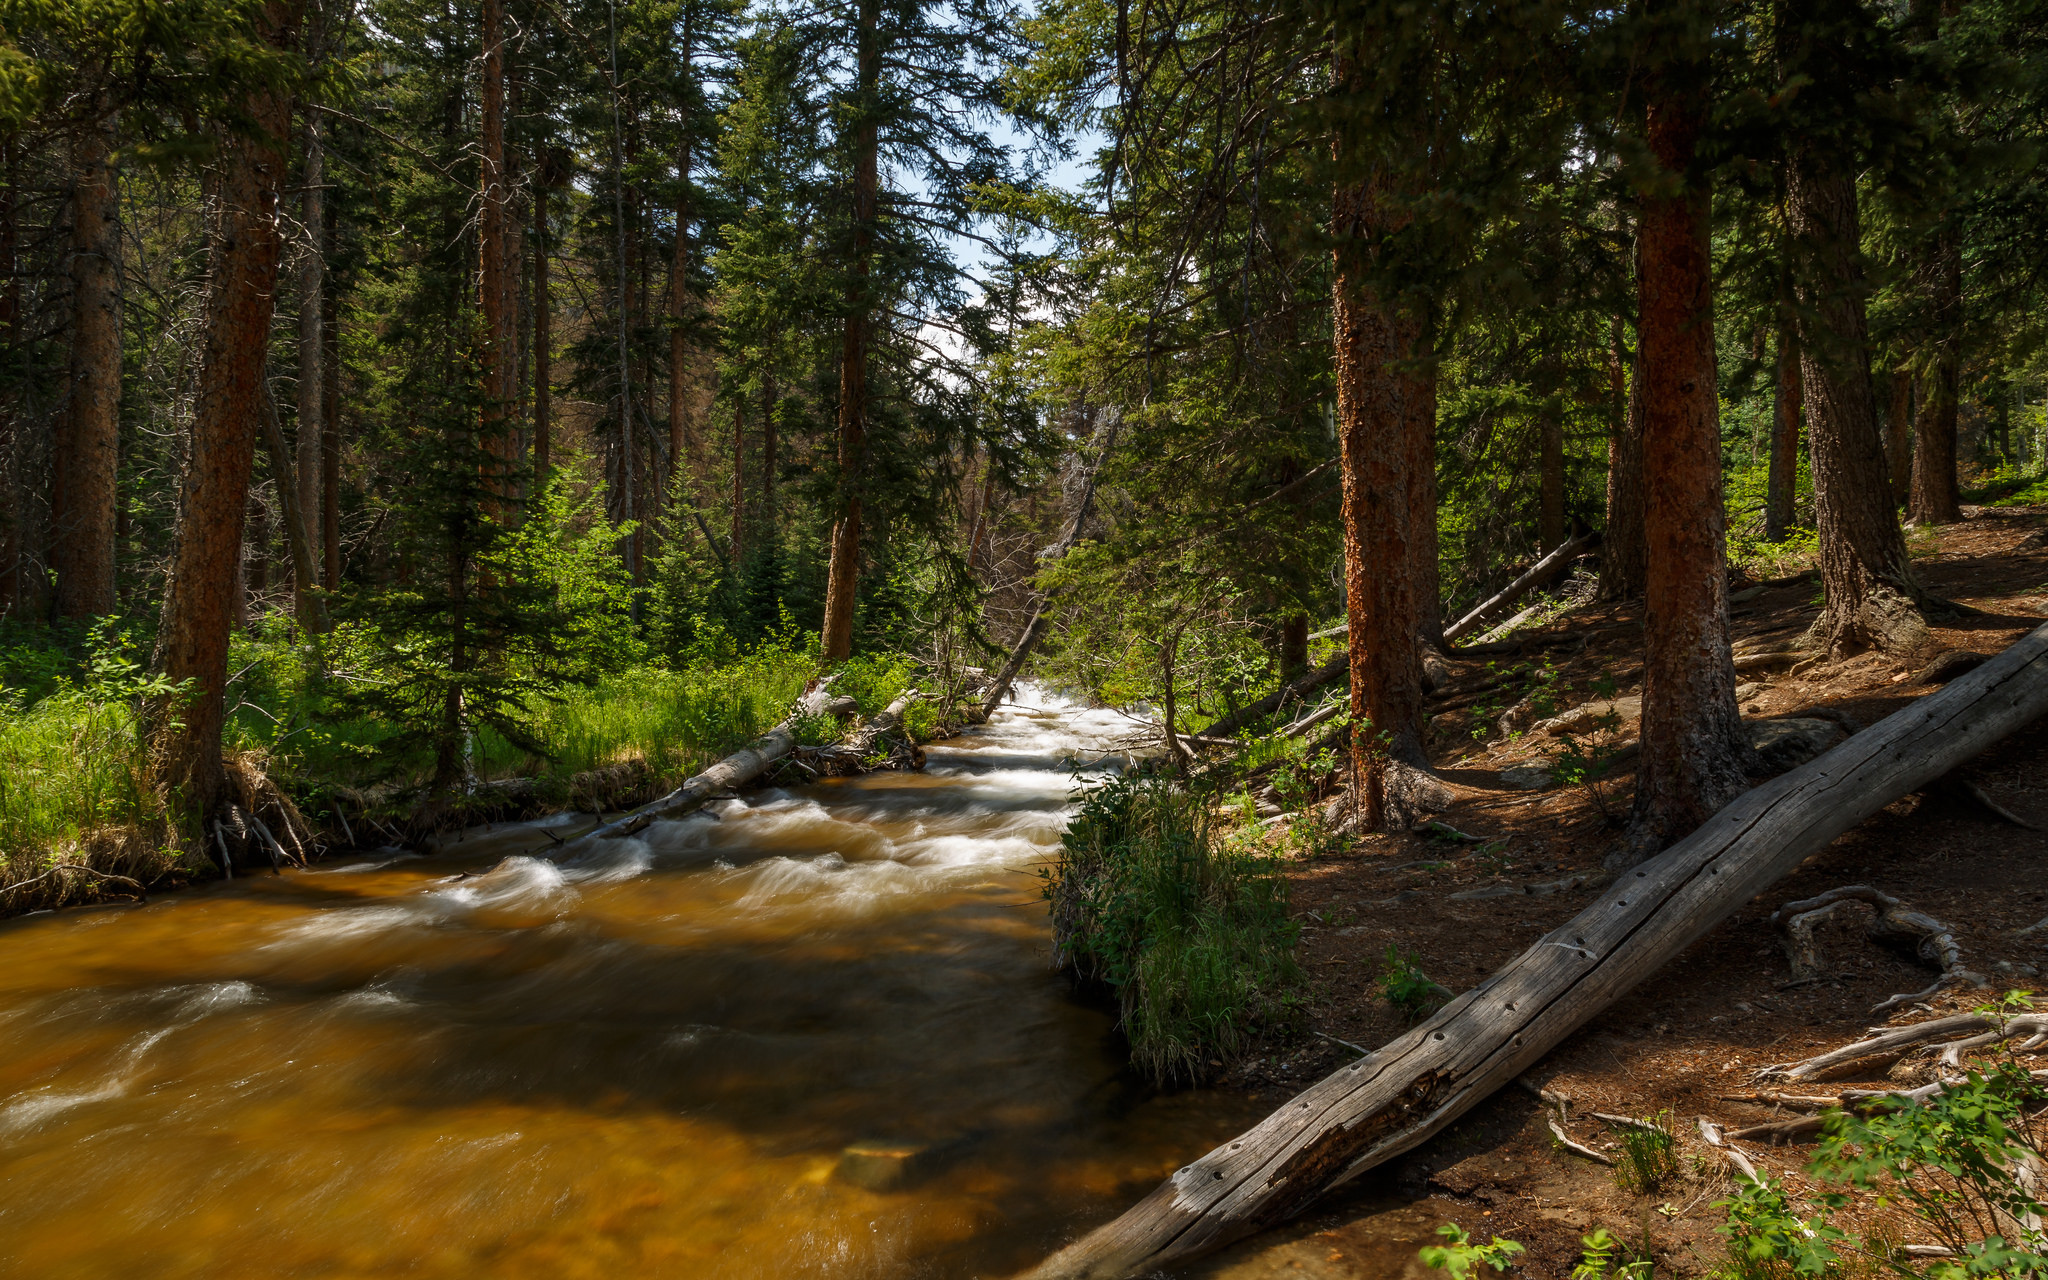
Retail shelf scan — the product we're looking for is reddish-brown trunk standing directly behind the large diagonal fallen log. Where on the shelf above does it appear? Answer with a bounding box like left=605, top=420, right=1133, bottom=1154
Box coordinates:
left=1624, top=74, right=1749, bottom=862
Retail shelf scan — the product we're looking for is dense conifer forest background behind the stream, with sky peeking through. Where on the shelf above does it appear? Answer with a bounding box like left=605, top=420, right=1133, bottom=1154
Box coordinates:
left=0, top=0, right=2048, bottom=897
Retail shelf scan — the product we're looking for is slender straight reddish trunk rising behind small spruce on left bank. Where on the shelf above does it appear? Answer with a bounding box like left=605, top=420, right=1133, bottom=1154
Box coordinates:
left=477, top=0, right=518, bottom=520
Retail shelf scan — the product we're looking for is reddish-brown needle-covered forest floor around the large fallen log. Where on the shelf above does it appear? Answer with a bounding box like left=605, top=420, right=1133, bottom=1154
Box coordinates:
left=1196, top=508, right=2048, bottom=1280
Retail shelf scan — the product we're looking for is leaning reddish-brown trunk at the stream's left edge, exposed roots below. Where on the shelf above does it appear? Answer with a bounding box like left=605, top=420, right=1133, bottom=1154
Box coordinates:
left=150, top=0, right=299, bottom=819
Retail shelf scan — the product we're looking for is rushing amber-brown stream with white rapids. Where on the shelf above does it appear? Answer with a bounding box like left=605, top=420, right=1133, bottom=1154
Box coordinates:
left=0, top=688, right=1294, bottom=1280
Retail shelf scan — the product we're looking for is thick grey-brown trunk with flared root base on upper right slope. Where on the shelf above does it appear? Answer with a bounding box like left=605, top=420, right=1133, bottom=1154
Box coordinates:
left=1778, top=0, right=1927, bottom=657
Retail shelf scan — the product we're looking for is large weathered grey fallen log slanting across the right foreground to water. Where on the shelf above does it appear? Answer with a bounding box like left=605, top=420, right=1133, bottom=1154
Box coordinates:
left=1030, top=614, right=2048, bottom=1280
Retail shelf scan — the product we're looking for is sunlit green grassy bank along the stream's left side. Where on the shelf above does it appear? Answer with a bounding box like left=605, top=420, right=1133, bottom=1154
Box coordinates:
left=0, top=625, right=930, bottom=915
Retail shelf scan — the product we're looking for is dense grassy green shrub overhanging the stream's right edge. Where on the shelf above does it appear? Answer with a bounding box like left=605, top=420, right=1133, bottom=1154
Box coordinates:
left=1042, top=774, right=1303, bottom=1083
